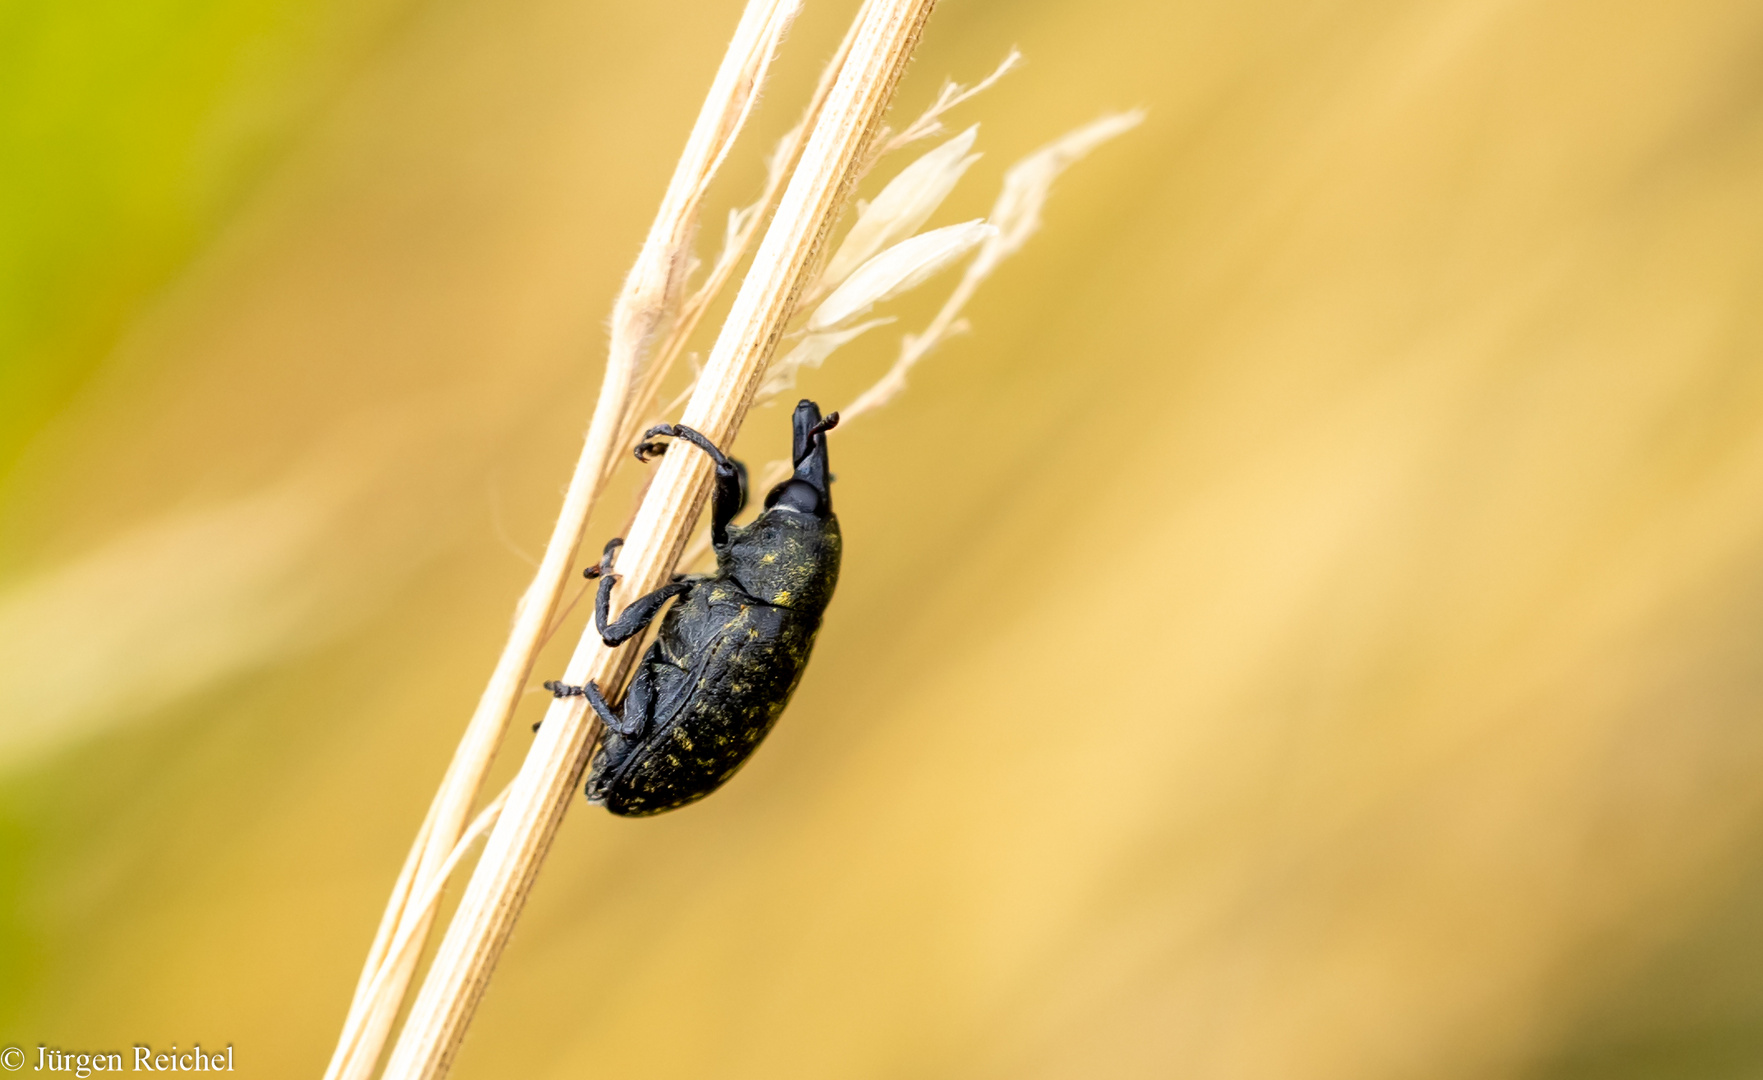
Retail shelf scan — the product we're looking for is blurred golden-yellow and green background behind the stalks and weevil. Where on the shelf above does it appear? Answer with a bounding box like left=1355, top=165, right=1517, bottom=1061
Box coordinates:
left=0, top=0, right=1763, bottom=1080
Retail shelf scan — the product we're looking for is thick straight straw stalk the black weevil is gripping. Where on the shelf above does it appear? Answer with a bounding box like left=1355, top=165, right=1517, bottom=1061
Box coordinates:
left=384, top=0, right=934, bottom=1080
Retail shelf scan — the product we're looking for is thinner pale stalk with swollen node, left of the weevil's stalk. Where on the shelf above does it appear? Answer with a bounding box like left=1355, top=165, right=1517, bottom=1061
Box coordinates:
left=324, top=0, right=800, bottom=1080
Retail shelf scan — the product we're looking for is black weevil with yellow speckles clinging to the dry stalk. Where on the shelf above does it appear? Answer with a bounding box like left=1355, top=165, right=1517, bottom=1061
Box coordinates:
left=545, top=400, right=841, bottom=816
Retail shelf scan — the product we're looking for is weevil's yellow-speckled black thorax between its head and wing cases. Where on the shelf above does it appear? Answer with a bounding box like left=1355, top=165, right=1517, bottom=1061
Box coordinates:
left=716, top=506, right=843, bottom=609
